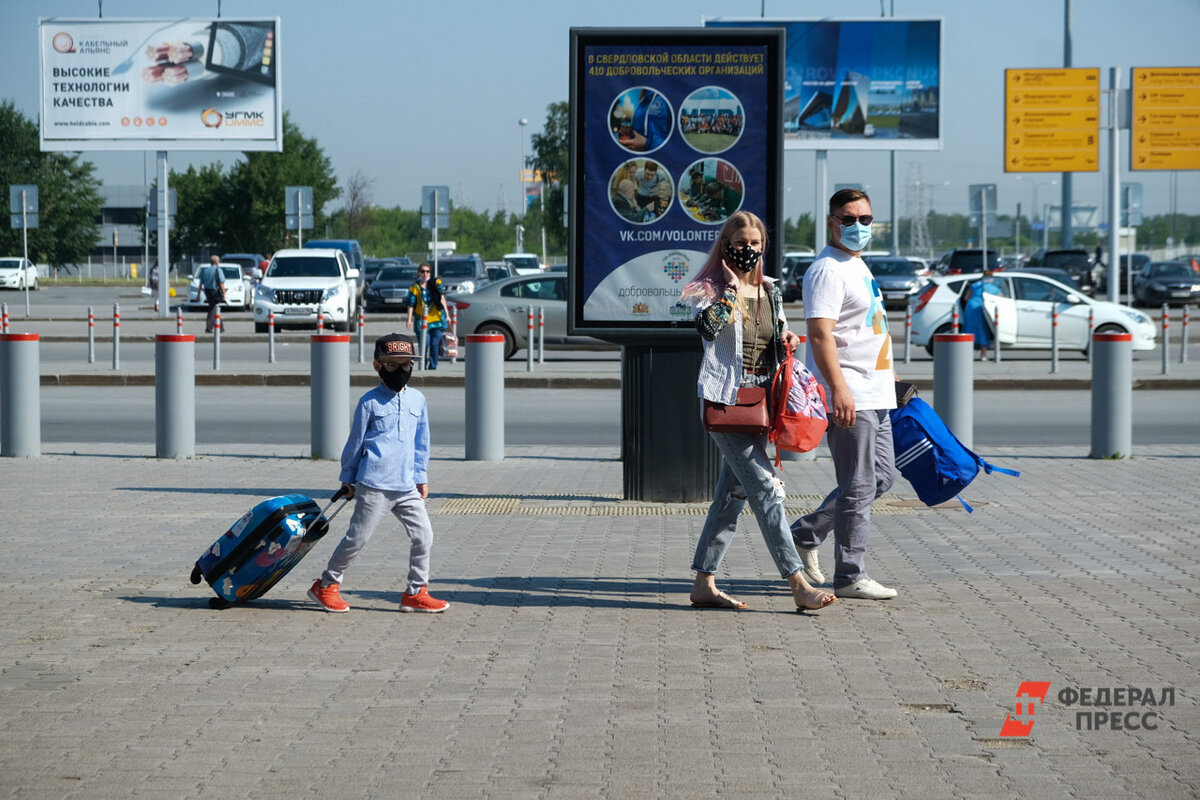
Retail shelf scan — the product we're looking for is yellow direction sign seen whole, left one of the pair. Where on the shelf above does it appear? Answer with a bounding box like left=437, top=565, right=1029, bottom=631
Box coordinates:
left=1004, top=67, right=1100, bottom=173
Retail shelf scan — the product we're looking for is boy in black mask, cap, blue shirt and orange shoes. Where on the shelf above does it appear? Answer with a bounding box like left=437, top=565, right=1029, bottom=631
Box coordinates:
left=308, top=333, right=450, bottom=614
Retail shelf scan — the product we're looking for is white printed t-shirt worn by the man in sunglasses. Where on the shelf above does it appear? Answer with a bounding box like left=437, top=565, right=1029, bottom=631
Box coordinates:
left=804, top=247, right=896, bottom=410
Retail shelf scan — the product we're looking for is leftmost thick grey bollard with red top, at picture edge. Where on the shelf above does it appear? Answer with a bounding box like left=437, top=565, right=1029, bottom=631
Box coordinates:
left=0, top=333, right=42, bottom=458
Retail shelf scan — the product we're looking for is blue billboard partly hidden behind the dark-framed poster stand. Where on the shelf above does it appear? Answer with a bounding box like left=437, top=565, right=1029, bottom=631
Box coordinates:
left=704, top=18, right=942, bottom=150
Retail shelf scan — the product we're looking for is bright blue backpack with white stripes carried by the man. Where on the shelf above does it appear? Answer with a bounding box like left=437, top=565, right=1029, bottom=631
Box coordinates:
left=892, top=397, right=1020, bottom=513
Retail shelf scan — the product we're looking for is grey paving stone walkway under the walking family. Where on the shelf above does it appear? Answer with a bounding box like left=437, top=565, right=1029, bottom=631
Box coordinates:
left=0, top=444, right=1200, bottom=800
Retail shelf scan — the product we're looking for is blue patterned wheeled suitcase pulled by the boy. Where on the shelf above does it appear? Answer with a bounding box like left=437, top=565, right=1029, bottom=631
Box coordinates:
left=192, top=489, right=346, bottom=608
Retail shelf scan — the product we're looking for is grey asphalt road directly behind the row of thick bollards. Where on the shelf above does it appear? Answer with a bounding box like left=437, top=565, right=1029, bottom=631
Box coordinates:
left=41, top=386, right=1200, bottom=449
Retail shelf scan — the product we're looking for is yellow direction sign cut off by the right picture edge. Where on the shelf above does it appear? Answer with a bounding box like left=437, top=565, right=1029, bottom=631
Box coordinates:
left=1129, top=67, right=1200, bottom=170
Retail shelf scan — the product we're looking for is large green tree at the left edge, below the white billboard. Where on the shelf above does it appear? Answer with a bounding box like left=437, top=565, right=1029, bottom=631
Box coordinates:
left=0, top=101, right=101, bottom=267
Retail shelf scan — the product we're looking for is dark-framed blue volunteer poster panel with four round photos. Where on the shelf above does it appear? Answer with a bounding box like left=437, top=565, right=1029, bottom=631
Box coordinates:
left=568, top=29, right=784, bottom=336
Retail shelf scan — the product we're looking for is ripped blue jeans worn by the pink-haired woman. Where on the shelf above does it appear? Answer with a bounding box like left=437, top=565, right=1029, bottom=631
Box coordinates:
left=691, top=433, right=804, bottom=578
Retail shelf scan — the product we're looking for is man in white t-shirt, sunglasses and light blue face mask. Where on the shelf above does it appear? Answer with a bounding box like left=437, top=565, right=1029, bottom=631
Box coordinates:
left=792, top=190, right=896, bottom=600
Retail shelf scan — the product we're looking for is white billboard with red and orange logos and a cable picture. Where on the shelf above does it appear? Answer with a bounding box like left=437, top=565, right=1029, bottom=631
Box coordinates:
left=38, top=18, right=283, bottom=151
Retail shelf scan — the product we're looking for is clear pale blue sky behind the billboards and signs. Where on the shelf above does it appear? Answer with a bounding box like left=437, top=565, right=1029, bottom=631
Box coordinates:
left=9, top=0, right=1200, bottom=235
